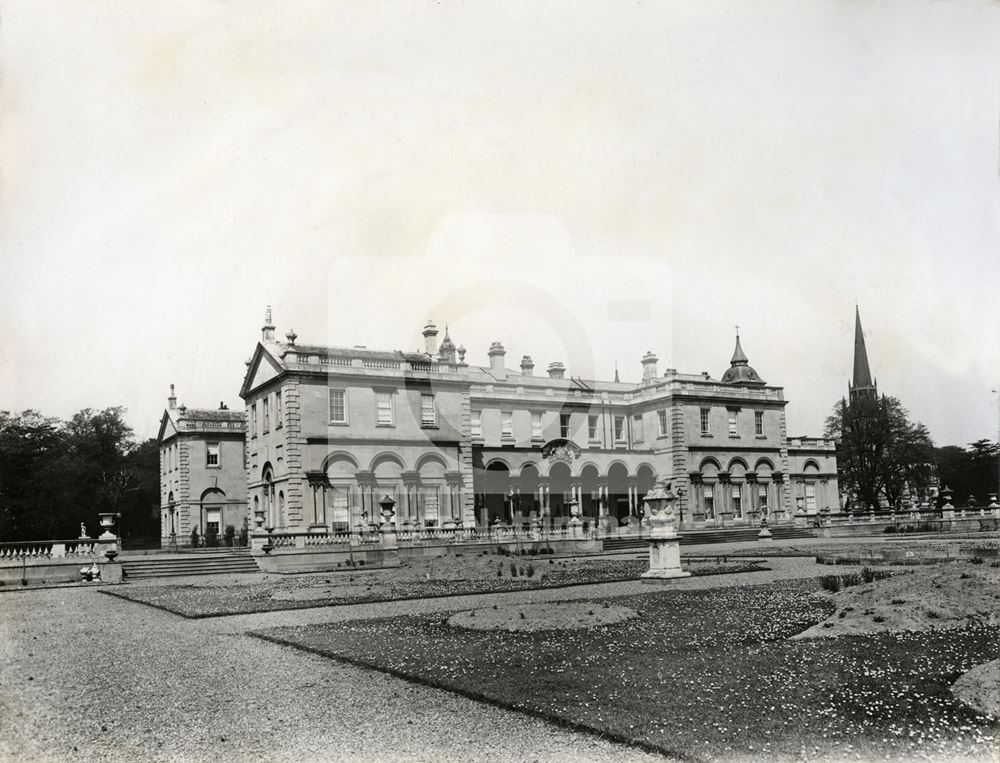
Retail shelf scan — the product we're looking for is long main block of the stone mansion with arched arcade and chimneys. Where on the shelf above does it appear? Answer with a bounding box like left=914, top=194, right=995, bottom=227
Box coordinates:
left=240, top=316, right=839, bottom=530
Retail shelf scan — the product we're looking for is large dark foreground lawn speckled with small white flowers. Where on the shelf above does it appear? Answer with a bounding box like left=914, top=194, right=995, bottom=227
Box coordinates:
left=258, top=581, right=1000, bottom=760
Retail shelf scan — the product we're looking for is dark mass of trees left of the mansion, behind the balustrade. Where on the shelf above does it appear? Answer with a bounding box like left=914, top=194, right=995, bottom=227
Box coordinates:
left=0, top=406, right=160, bottom=541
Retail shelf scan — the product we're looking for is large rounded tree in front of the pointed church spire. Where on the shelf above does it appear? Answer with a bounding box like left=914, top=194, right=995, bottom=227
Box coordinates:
left=826, top=395, right=934, bottom=508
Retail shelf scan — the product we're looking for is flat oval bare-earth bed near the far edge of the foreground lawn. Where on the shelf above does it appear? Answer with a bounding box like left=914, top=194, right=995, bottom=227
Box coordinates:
left=448, top=601, right=639, bottom=631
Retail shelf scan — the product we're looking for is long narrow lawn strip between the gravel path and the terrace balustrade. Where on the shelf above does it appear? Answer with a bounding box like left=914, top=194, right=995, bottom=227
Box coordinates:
left=101, top=556, right=768, bottom=618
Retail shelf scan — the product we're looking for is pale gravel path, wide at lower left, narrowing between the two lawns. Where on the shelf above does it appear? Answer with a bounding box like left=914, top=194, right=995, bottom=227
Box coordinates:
left=0, top=559, right=818, bottom=761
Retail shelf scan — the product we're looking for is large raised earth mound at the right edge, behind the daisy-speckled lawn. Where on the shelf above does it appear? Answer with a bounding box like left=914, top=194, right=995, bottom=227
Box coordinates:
left=792, top=562, right=1000, bottom=639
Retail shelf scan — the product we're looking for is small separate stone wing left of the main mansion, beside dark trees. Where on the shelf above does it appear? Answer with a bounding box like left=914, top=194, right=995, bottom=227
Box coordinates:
left=157, top=385, right=247, bottom=547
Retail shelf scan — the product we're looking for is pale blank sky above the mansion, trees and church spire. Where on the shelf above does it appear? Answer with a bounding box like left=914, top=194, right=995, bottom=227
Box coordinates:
left=0, top=0, right=1000, bottom=445
